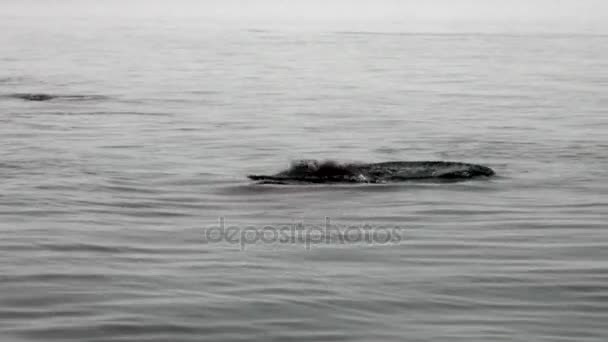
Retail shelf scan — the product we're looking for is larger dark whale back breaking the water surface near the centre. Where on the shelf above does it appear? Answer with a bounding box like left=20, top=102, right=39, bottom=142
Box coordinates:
left=248, top=160, right=495, bottom=184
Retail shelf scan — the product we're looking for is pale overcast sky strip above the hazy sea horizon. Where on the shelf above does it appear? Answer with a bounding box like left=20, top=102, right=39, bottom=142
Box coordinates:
left=0, top=0, right=608, bottom=34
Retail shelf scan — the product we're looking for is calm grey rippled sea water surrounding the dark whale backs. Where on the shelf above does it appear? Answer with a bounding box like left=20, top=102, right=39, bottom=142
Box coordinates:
left=0, top=2, right=608, bottom=342
